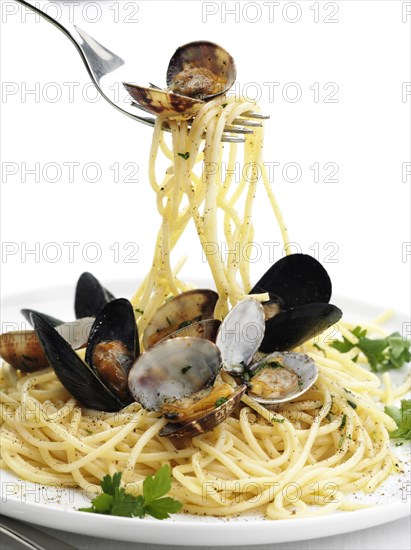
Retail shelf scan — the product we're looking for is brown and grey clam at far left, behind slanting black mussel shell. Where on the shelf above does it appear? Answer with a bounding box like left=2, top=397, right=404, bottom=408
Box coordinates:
left=0, top=316, right=94, bottom=372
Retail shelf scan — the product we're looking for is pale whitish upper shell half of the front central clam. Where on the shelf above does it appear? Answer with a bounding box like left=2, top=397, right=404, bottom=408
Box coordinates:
left=128, top=337, right=221, bottom=411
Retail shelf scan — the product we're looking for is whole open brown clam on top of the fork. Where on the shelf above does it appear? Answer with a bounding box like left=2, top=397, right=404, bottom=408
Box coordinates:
left=123, top=41, right=236, bottom=120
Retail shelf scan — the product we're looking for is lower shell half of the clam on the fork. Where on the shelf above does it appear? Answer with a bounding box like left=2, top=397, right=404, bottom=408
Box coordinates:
left=123, top=82, right=204, bottom=120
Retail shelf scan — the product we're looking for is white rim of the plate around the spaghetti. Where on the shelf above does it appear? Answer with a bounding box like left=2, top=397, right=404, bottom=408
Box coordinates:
left=0, top=279, right=409, bottom=546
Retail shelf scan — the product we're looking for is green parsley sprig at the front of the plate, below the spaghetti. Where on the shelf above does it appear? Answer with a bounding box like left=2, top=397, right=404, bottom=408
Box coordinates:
left=79, top=464, right=183, bottom=519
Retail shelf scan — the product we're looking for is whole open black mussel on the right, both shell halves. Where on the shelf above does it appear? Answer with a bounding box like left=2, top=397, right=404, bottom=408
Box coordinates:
left=250, top=254, right=342, bottom=353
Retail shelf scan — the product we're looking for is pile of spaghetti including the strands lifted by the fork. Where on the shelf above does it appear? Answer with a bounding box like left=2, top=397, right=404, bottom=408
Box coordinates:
left=0, top=98, right=409, bottom=519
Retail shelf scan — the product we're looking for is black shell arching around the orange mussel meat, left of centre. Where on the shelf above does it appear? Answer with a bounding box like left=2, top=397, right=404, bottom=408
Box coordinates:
left=85, top=298, right=140, bottom=372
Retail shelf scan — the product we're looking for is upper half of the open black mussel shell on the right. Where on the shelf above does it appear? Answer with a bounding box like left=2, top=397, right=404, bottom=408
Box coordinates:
left=250, top=254, right=331, bottom=309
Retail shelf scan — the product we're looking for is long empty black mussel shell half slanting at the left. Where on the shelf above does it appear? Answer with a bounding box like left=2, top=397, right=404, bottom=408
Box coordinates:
left=31, top=313, right=127, bottom=412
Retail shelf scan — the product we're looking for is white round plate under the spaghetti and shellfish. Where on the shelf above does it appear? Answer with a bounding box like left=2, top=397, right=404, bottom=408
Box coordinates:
left=1, top=282, right=410, bottom=546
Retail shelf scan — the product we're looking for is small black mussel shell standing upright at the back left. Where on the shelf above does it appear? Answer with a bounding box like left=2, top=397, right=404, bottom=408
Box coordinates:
left=74, top=272, right=114, bottom=319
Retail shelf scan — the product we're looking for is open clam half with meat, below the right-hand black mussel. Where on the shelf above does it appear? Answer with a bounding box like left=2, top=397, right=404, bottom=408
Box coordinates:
left=247, top=351, right=318, bottom=405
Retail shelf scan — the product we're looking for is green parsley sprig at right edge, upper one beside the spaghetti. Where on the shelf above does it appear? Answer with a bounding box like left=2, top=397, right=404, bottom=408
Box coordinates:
left=330, top=327, right=411, bottom=372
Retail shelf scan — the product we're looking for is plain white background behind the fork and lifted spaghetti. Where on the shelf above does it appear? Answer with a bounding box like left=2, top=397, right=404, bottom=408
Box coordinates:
left=0, top=0, right=411, bottom=548
